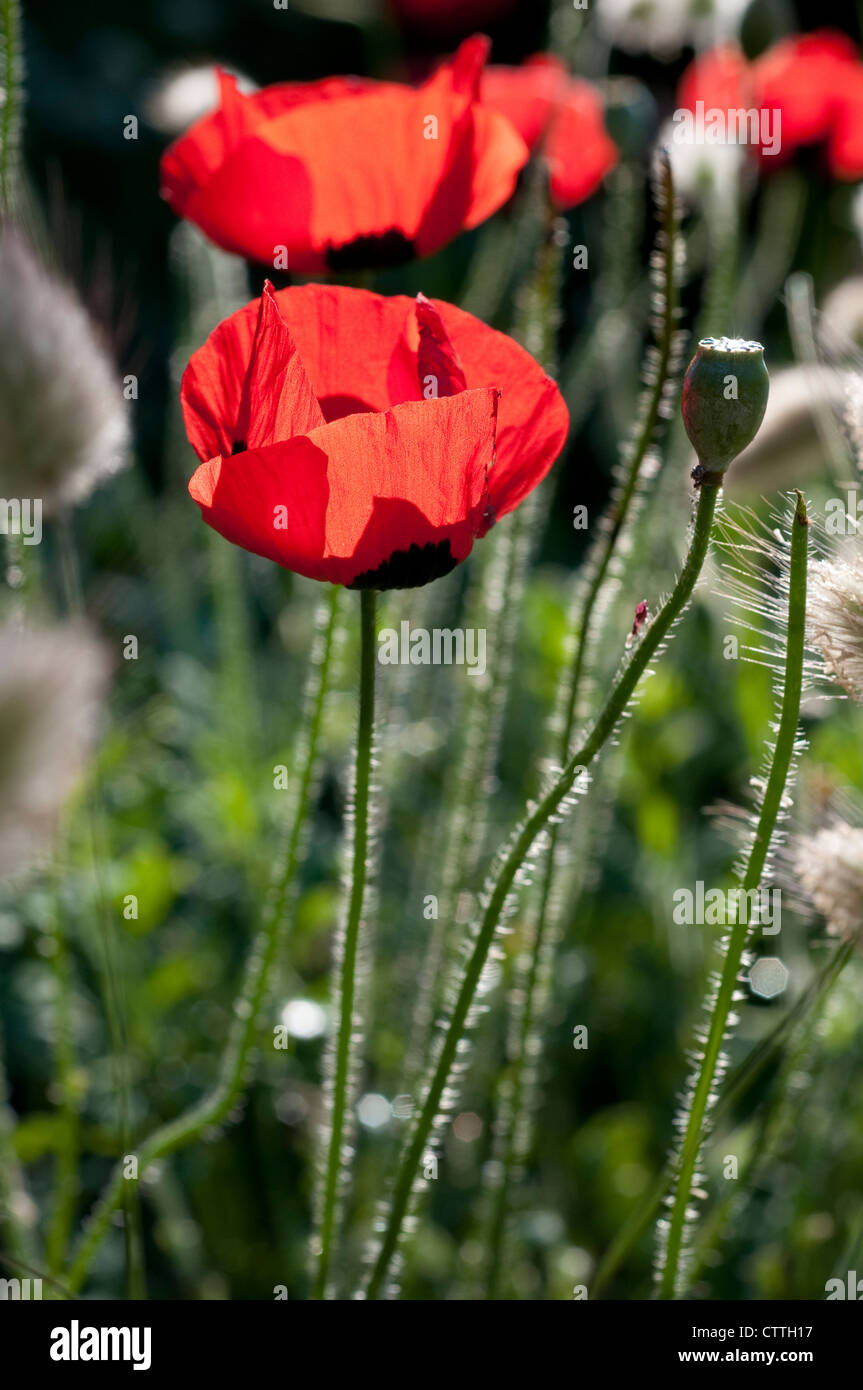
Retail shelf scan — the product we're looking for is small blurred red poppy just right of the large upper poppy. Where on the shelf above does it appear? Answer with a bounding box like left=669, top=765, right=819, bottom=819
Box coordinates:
left=481, top=54, right=617, bottom=209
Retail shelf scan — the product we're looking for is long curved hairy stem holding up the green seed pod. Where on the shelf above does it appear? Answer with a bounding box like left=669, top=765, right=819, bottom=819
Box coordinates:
left=367, top=482, right=718, bottom=1298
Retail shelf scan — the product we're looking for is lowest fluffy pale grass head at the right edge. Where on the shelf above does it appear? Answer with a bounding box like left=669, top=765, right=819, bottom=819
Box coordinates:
left=794, top=820, right=863, bottom=941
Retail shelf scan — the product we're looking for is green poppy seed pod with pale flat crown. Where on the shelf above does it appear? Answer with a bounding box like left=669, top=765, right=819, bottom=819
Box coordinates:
left=682, top=338, right=770, bottom=484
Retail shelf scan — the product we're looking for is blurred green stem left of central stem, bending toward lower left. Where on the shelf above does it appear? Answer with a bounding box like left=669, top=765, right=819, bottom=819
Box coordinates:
left=65, top=587, right=339, bottom=1294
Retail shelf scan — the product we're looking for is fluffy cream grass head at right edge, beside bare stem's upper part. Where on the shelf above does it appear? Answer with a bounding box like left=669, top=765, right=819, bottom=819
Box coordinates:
left=806, top=545, right=863, bottom=701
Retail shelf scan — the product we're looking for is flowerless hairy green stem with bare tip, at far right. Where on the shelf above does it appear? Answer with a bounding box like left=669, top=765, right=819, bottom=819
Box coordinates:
left=657, top=492, right=809, bottom=1298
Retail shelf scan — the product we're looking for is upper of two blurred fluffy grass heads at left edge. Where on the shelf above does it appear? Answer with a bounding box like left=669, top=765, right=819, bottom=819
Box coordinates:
left=0, top=231, right=129, bottom=513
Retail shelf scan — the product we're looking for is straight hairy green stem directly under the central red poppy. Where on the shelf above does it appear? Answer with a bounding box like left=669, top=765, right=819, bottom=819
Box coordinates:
left=313, top=589, right=377, bottom=1298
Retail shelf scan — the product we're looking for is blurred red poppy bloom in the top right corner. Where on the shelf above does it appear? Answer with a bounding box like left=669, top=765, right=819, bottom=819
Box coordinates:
left=678, top=31, right=863, bottom=179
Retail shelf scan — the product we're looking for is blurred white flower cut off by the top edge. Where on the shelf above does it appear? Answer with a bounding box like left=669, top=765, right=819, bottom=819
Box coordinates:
left=593, top=0, right=752, bottom=58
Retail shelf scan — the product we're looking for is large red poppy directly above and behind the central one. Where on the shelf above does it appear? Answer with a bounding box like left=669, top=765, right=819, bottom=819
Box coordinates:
left=161, top=36, right=528, bottom=271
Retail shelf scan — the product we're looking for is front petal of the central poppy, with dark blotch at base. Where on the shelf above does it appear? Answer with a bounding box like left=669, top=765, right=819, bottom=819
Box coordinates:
left=189, top=389, right=498, bottom=588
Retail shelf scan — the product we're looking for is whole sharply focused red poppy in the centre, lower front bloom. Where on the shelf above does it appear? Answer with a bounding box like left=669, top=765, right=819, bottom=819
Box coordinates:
left=181, top=284, right=568, bottom=588
